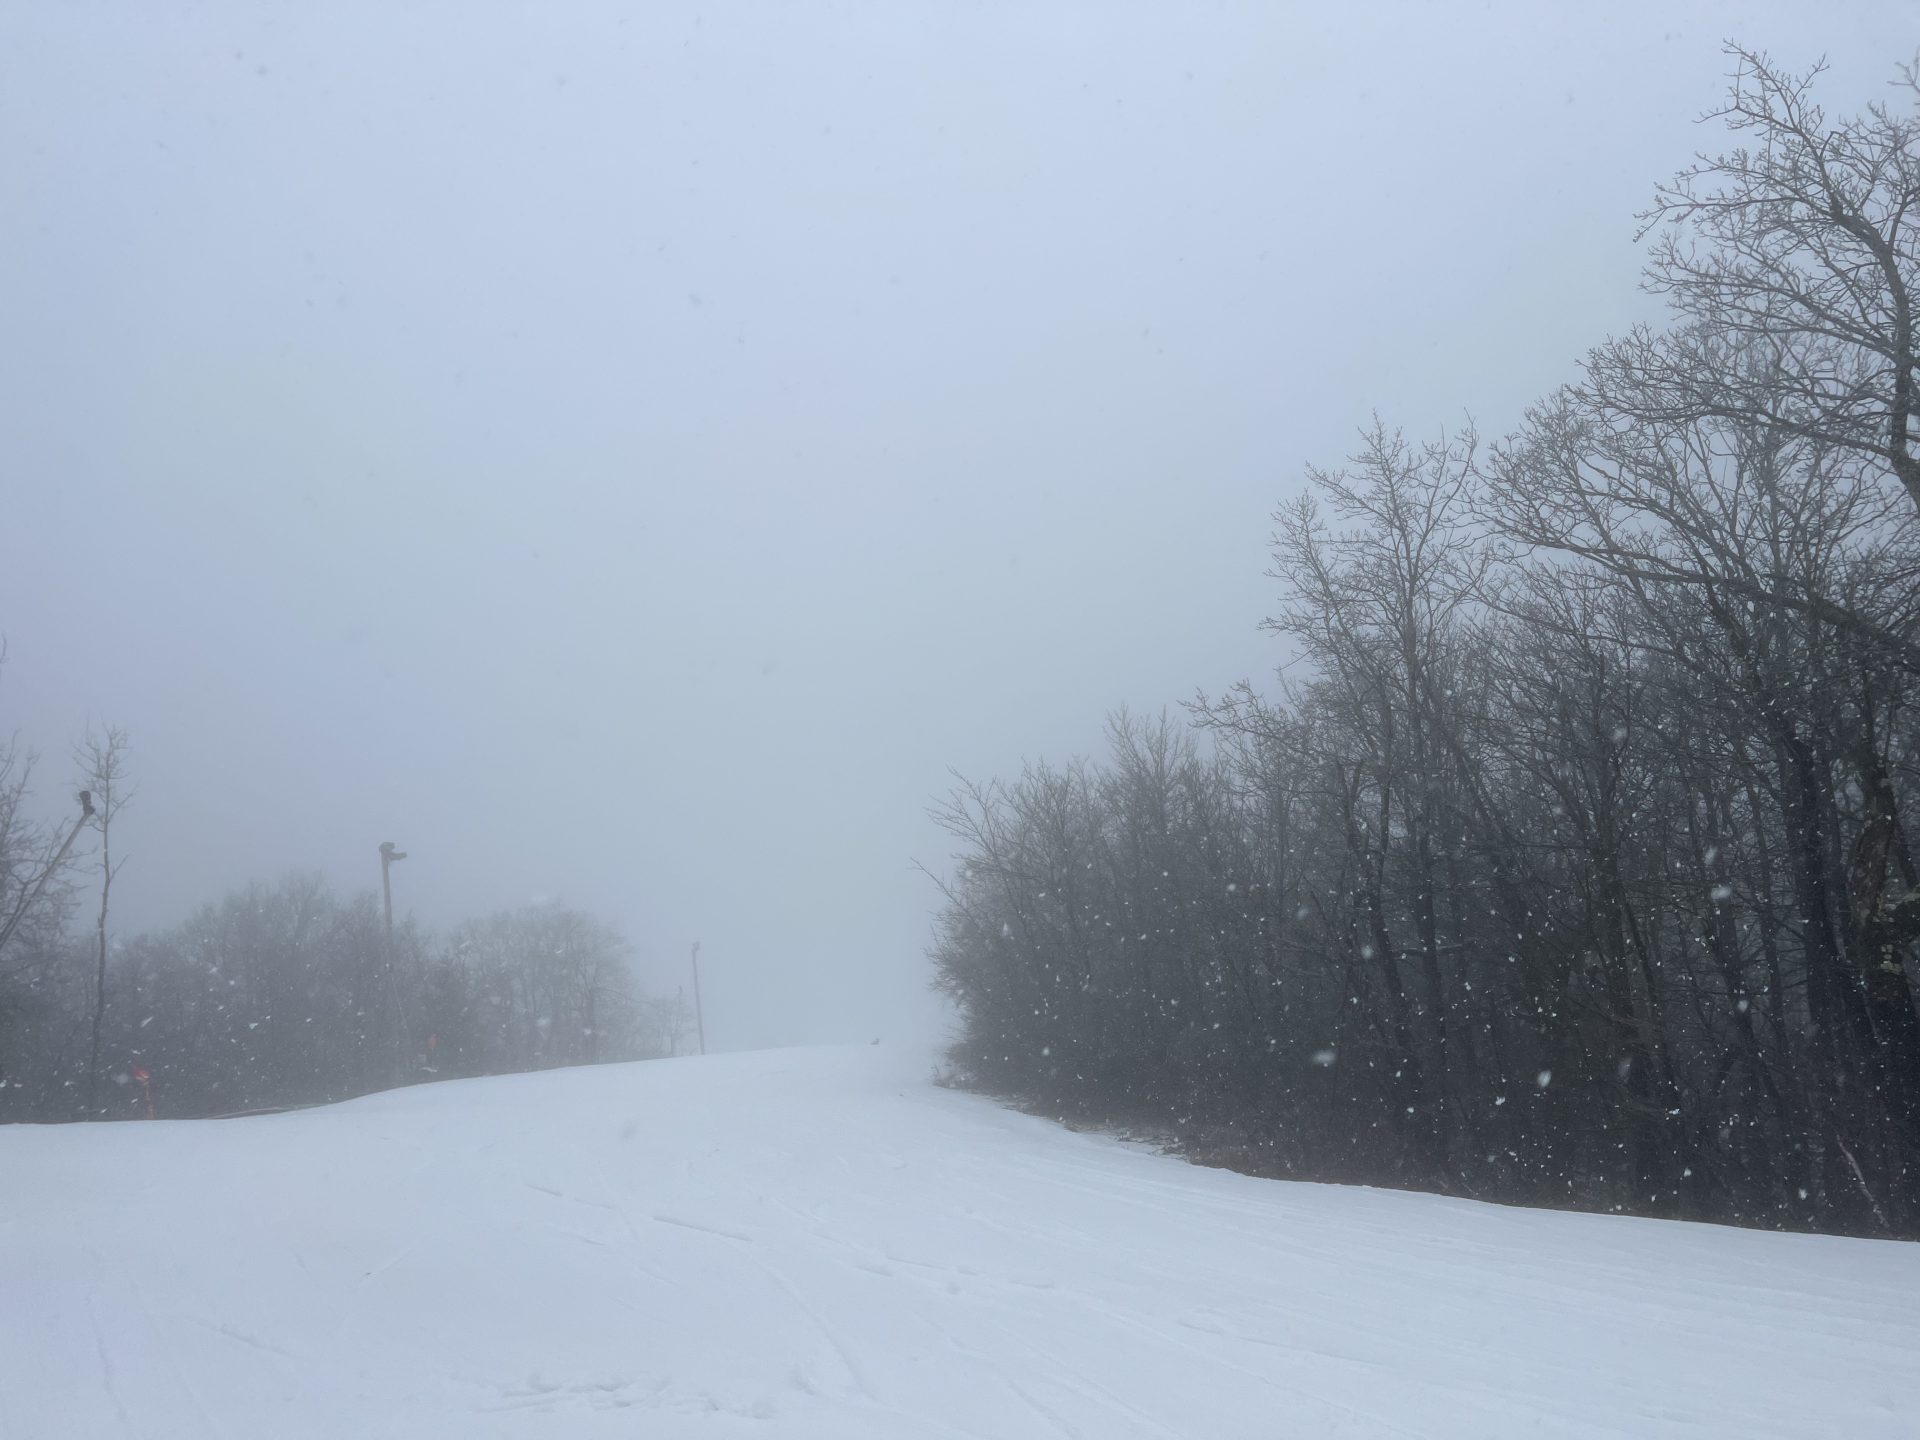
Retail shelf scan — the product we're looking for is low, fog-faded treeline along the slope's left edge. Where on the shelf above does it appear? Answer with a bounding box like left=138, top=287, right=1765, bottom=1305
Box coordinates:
left=0, top=732, right=691, bottom=1121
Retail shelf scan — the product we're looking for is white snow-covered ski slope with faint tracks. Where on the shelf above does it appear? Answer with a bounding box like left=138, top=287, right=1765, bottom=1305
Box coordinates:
left=0, top=1046, right=1920, bottom=1440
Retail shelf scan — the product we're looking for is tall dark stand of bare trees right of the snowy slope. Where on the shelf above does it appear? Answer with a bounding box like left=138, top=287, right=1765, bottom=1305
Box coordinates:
left=933, top=54, right=1920, bottom=1235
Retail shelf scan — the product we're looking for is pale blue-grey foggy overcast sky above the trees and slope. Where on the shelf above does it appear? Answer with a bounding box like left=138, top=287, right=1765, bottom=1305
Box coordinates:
left=0, top=0, right=1920, bottom=1048
